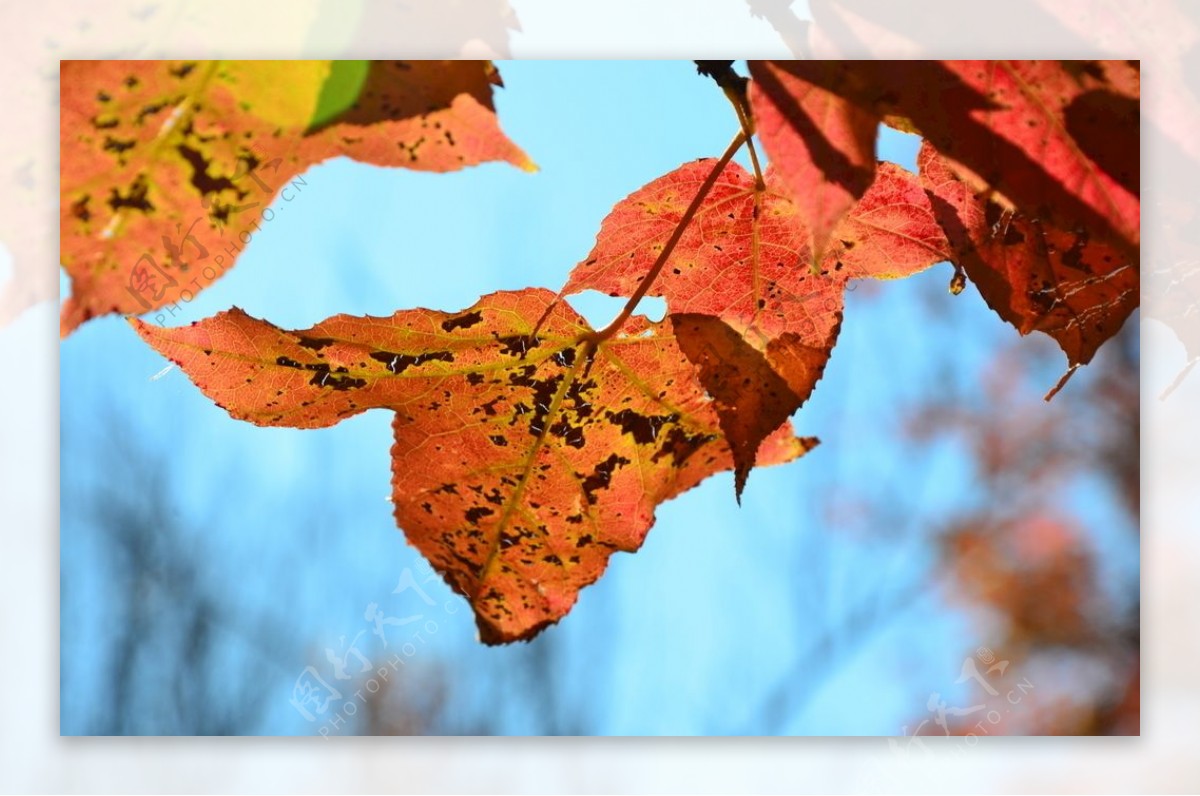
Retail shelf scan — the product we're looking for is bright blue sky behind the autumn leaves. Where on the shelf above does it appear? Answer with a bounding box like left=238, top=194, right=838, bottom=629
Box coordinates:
left=61, top=61, right=1138, bottom=735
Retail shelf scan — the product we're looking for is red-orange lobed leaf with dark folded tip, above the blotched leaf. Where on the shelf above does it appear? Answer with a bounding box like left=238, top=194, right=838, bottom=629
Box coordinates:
left=563, top=160, right=949, bottom=487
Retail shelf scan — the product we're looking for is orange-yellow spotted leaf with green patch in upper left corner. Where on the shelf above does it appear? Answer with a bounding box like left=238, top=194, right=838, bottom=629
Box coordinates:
left=60, top=61, right=533, bottom=335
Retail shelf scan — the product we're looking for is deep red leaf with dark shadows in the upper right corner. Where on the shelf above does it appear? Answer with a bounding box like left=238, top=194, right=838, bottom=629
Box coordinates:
left=758, top=61, right=1140, bottom=257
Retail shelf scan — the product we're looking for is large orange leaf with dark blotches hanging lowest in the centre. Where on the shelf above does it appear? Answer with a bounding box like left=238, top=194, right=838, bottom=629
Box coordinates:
left=132, top=288, right=816, bottom=644
